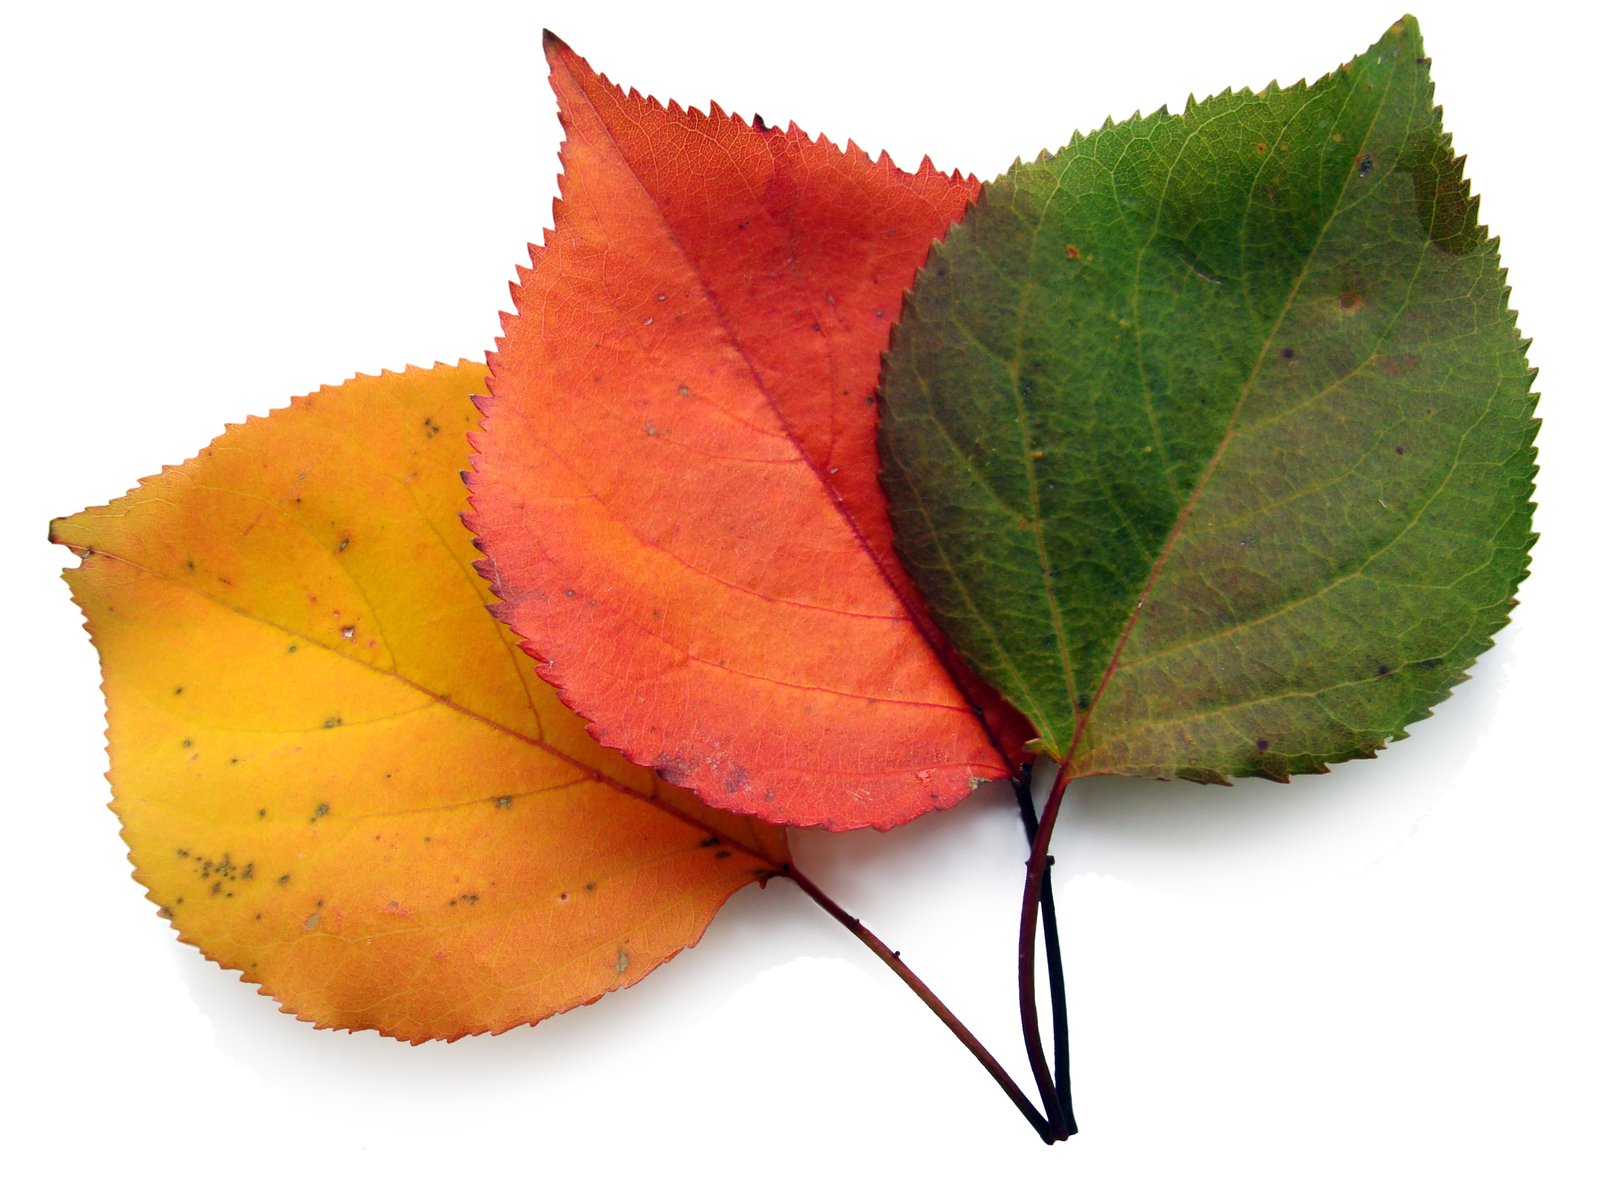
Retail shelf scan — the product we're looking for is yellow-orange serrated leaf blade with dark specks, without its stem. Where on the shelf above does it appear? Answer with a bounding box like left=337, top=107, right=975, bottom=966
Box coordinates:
left=51, top=363, right=787, bottom=1042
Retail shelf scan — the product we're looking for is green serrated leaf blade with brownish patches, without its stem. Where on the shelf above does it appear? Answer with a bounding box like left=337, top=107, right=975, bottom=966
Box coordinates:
left=883, top=19, right=1536, bottom=781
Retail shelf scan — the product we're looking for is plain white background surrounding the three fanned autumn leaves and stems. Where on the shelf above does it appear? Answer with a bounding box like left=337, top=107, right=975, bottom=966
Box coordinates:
left=0, top=0, right=1600, bottom=1197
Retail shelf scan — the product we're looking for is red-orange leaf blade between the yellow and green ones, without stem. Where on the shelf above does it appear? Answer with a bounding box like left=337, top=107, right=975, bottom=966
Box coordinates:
left=469, top=37, right=1027, bottom=829
